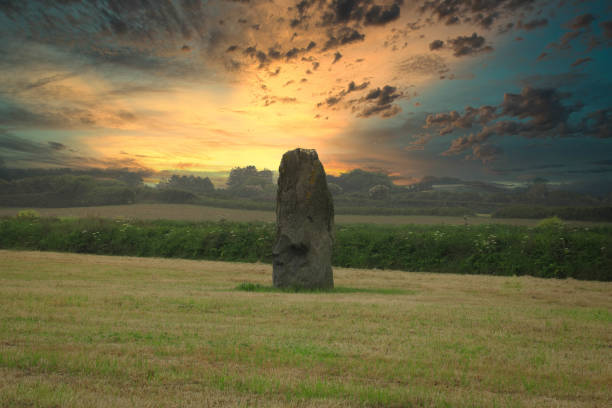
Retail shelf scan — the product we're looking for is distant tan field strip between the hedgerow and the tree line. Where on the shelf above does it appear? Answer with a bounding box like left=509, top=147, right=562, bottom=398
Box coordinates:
left=0, top=204, right=602, bottom=226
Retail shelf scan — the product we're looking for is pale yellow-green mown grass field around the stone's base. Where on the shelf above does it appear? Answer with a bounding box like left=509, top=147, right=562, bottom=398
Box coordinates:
left=0, top=251, right=612, bottom=407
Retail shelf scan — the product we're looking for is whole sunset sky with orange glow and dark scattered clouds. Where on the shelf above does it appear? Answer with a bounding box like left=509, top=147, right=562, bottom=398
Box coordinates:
left=0, top=0, right=612, bottom=188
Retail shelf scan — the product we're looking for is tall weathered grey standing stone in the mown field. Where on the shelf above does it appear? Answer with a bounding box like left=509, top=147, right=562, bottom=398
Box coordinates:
left=272, top=149, right=334, bottom=289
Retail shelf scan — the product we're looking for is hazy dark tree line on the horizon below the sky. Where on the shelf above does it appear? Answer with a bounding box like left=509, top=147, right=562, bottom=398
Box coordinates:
left=0, top=166, right=612, bottom=220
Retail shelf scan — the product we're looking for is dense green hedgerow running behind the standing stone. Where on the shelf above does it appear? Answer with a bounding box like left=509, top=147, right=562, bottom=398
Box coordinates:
left=0, top=217, right=612, bottom=281
